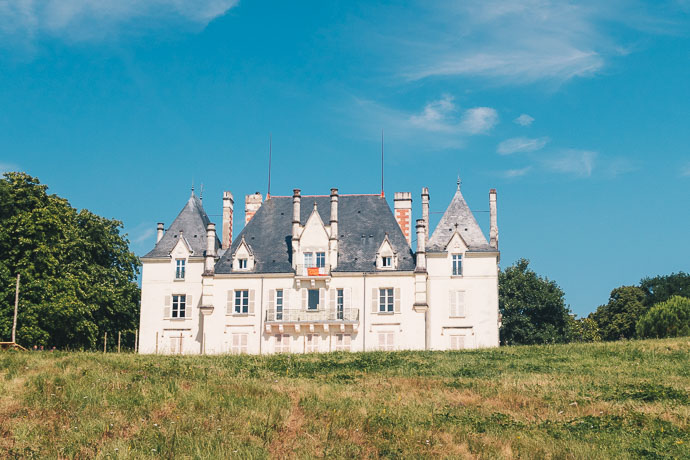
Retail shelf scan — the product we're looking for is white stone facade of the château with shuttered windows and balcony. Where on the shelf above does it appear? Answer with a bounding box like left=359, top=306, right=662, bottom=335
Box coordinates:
left=139, top=183, right=499, bottom=354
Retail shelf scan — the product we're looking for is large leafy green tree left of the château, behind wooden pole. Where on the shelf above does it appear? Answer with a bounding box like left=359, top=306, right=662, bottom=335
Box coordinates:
left=0, top=173, right=139, bottom=348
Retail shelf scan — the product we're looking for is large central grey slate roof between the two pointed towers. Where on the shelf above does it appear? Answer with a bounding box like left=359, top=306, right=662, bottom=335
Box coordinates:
left=215, top=195, right=415, bottom=273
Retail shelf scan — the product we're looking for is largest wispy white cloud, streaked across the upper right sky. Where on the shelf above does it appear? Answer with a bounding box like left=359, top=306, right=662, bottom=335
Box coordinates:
left=384, top=0, right=682, bottom=84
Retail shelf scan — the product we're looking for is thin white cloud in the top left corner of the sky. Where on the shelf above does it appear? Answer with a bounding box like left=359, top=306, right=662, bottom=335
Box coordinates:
left=0, top=0, right=238, bottom=40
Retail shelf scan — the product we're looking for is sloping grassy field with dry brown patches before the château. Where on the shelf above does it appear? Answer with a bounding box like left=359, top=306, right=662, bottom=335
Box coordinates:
left=0, top=338, right=690, bottom=459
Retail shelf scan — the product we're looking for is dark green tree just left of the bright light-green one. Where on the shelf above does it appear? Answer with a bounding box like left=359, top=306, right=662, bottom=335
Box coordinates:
left=590, top=286, right=647, bottom=340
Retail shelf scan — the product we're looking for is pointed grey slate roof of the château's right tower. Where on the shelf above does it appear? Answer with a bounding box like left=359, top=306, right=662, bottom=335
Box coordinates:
left=426, top=186, right=496, bottom=252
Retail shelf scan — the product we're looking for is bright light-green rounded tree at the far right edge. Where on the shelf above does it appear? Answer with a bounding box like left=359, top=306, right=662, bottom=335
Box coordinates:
left=636, top=295, right=690, bottom=338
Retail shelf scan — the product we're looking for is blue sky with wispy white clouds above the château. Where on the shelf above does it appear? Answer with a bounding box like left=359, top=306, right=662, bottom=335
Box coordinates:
left=0, top=0, right=690, bottom=316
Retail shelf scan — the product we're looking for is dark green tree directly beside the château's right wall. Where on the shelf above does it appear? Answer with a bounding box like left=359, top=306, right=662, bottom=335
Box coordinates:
left=498, top=259, right=570, bottom=345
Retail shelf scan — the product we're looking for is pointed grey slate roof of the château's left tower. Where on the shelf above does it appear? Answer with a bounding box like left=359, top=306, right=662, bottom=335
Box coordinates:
left=143, top=193, right=220, bottom=259
